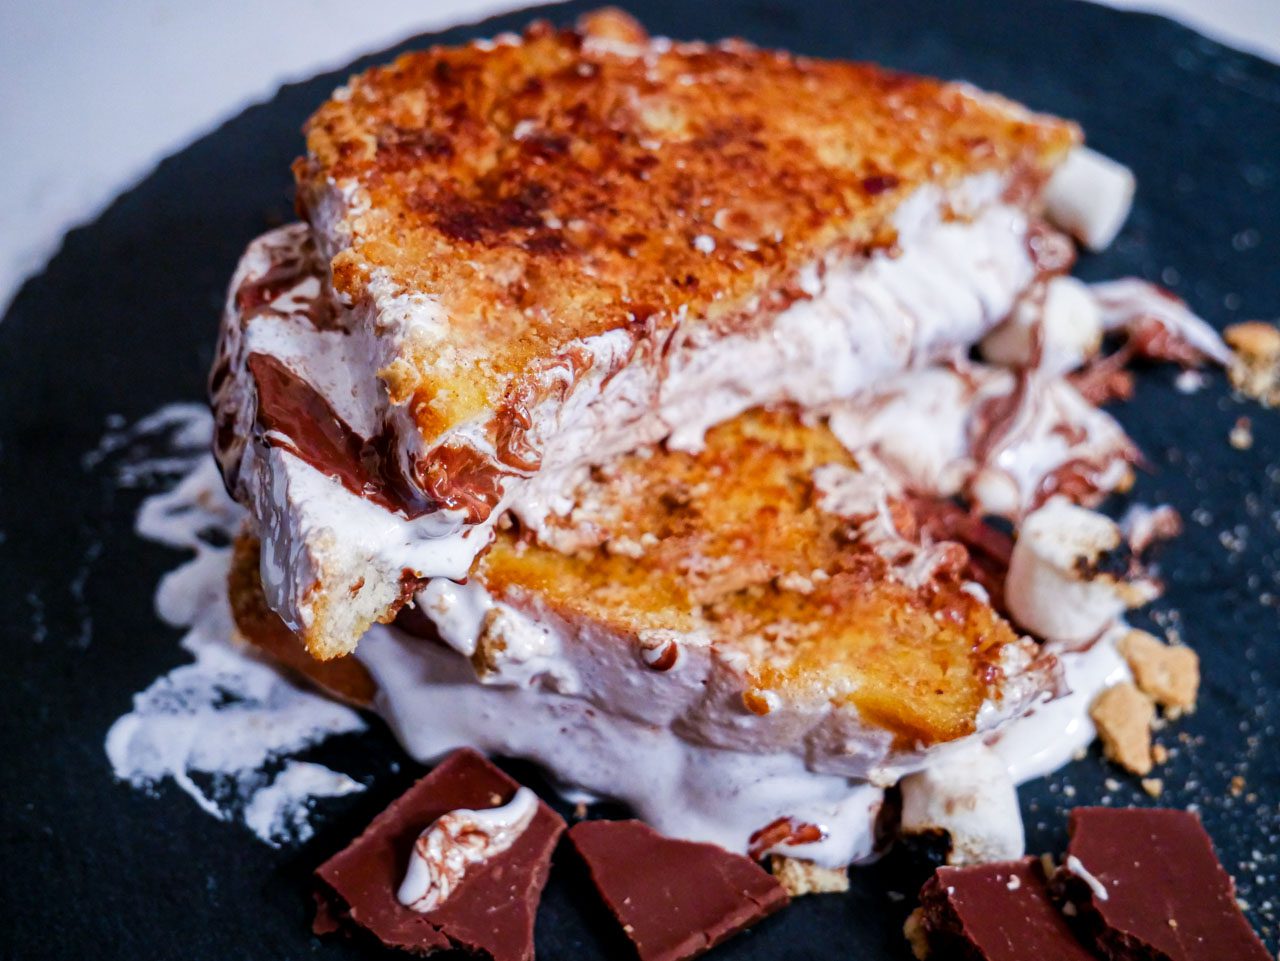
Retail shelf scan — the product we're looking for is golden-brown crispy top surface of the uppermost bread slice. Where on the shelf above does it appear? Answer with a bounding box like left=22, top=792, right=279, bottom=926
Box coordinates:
left=294, top=13, right=1078, bottom=438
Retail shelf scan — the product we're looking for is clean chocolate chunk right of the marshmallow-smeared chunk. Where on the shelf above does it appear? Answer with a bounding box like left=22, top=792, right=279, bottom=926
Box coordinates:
left=568, top=820, right=788, bottom=961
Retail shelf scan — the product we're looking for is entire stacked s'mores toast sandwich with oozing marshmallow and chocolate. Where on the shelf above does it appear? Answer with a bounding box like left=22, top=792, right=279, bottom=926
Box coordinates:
left=211, top=10, right=1208, bottom=866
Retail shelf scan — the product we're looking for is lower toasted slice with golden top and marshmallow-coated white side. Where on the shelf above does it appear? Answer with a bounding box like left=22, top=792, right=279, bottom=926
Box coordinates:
left=419, top=409, right=1055, bottom=777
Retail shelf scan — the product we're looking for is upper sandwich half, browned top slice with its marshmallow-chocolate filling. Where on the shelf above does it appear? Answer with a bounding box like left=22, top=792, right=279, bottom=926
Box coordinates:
left=212, top=14, right=1078, bottom=658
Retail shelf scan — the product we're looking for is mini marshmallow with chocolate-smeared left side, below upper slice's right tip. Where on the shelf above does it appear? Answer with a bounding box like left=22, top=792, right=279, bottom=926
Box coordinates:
left=982, top=276, right=1102, bottom=374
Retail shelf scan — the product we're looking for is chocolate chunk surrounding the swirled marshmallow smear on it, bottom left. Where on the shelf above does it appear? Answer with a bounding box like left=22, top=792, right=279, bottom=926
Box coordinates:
left=314, top=750, right=564, bottom=961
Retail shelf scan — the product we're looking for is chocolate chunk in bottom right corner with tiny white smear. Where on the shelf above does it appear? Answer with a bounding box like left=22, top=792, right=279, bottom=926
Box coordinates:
left=1053, top=807, right=1270, bottom=961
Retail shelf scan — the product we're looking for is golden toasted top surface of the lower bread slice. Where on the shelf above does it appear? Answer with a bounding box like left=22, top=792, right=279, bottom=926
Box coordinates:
left=474, top=411, right=1015, bottom=743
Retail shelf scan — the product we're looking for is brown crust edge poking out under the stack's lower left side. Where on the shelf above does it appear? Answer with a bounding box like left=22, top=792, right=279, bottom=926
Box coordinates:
left=227, top=534, right=378, bottom=708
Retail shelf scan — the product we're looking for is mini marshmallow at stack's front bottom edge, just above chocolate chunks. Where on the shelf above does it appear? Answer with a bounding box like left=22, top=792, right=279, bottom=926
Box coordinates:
left=901, top=743, right=1024, bottom=865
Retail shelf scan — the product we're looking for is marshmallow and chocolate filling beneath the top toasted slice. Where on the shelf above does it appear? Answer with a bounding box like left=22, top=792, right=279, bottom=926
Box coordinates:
left=211, top=187, right=1048, bottom=656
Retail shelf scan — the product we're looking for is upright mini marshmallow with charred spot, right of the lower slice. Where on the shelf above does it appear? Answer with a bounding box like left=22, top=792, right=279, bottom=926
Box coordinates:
left=1005, top=498, right=1155, bottom=645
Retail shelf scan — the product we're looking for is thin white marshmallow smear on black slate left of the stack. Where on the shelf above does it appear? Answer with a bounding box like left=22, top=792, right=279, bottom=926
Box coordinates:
left=103, top=404, right=365, bottom=845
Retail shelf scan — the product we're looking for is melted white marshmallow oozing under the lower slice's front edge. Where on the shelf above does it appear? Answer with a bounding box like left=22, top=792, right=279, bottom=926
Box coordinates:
left=356, top=626, right=882, bottom=866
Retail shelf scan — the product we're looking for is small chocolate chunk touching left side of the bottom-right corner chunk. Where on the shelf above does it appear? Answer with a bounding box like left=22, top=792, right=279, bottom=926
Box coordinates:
left=918, top=857, right=1094, bottom=961
